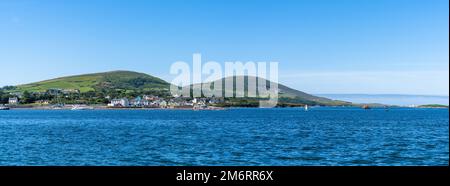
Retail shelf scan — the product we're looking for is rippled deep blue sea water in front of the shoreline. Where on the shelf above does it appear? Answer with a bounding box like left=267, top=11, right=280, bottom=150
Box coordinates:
left=0, top=107, right=449, bottom=166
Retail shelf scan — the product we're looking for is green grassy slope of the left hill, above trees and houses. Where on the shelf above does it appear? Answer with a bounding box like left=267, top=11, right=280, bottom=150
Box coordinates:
left=15, top=71, right=169, bottom=92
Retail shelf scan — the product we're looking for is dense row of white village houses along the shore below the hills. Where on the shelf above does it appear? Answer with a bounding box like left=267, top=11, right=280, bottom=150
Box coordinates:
left=108, top=95, right=223, bottom=108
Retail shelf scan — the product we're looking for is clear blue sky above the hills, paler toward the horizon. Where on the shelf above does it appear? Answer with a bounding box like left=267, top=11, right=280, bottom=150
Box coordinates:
left=0, top=0, right=449, bottom=95
